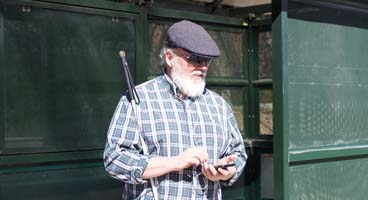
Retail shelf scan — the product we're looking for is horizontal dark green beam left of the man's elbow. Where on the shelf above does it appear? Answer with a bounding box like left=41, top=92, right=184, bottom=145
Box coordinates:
left=0, top=150, right=103, bottom=169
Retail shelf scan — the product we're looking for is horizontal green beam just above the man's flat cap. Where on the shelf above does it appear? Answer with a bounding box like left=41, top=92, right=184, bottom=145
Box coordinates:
left=148, top=8, right=244, bottom=27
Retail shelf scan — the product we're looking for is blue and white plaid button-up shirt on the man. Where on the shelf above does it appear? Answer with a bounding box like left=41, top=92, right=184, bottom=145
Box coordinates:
left=104, top=75, right=247, bottom=200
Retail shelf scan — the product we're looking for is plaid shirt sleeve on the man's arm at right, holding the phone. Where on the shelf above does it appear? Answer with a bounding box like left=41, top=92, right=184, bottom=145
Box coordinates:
left=221, top=104, right=248, bottom=186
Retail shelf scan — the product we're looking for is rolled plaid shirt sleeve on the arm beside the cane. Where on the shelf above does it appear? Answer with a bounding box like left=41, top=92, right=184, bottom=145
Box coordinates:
left=103, top=96, right=151, bottom=184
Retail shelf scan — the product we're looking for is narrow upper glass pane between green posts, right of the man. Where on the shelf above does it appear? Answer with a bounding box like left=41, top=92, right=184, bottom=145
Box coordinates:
left=258, top=31, right=272, bottom=78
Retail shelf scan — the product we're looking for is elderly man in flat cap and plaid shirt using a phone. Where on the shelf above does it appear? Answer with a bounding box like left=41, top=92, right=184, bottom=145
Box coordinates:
left=104, top=21, right=247, bottom=199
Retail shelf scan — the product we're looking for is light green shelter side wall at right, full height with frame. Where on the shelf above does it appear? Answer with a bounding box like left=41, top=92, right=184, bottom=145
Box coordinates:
left=273, top=1, right=368, bottom=200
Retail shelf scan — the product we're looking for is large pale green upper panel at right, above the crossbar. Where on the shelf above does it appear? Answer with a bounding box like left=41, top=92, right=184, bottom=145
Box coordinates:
left=286, top=19, right=368, bottom=148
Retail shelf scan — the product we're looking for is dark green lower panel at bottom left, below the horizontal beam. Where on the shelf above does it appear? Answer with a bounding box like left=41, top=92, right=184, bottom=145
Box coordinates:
left=0, top=167, right=122, bottom=200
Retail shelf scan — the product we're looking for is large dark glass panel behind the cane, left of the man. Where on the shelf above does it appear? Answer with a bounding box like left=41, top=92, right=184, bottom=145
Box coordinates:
left=1, top=5, right=135, bottom=154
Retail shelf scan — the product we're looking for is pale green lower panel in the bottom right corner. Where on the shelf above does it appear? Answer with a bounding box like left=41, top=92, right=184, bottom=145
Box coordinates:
left=289, top=158, right=368, bottom=200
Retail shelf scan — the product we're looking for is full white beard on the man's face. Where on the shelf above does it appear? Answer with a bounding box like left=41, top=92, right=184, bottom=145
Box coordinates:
left=172, top=61, right=206, bottom=98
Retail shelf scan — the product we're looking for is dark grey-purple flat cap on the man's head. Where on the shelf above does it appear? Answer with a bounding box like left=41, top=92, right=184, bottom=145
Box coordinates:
left=165, top=20, right=220, bottom=58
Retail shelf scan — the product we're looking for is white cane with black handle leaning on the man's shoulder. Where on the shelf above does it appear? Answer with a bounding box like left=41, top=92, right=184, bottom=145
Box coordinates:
left=119, top=51, right=158, bottom=200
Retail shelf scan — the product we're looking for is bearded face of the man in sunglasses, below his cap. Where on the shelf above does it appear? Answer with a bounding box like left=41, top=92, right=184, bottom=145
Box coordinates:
left=169, top=49, right=211, bottom=97
